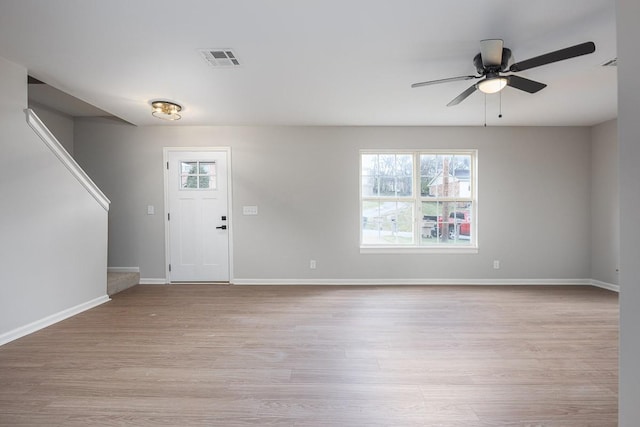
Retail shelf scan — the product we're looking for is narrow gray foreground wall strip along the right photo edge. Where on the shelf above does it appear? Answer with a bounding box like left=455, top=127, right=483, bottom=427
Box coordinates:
left=616, top=0, right=640, bottom=427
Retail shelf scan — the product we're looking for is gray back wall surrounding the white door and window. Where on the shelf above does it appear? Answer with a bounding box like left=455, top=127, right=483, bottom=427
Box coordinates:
left=74, top=119, right=591, bottom=281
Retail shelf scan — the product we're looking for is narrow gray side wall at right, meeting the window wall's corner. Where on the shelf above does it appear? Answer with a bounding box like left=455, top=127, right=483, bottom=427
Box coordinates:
left=589, top=120, right=620, bottom=285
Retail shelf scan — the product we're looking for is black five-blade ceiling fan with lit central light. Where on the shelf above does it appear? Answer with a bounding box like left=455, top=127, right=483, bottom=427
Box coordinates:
left=411, top=39, right=596, bottom=107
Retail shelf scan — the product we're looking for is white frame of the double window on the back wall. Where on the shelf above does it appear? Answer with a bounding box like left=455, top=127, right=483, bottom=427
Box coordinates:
left=358, top=149, right=478, bottom=254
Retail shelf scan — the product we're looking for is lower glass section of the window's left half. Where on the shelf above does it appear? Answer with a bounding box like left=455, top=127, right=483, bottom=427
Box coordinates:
left=362, top=201, right=414, bottom=245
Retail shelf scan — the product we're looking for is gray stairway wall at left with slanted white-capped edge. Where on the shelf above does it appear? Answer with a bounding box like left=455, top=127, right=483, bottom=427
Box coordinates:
left=0, top=54, right=107, bottom=342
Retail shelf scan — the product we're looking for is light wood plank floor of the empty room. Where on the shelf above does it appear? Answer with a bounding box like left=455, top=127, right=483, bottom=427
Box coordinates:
left=0, top=285, right=618, bottom=427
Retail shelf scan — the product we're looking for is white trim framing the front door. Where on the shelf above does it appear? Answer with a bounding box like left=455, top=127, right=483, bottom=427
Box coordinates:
left=162, top=146, right=233, bottom=284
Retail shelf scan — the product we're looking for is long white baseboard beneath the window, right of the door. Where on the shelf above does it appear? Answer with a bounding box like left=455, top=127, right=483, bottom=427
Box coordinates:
left=232, top=279, right=592, bottom=286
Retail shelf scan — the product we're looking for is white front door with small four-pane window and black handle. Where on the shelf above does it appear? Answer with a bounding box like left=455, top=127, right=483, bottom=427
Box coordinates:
left=165, top=149, right=230, bottom=282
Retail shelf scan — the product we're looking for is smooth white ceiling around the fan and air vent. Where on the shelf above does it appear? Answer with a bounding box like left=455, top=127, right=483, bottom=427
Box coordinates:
left=0, top=0, right=617, bottom=126
